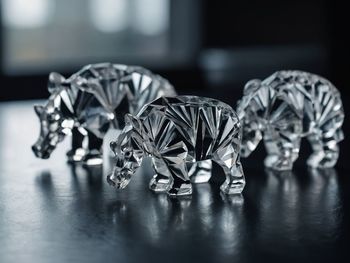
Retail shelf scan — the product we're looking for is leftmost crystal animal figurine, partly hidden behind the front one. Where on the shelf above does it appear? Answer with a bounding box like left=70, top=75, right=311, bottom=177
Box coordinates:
left=32, top=63, right=175, bottom=165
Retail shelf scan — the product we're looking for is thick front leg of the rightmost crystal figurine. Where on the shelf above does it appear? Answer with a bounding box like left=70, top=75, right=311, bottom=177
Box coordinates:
left=264, top=129, right=301, bottom=171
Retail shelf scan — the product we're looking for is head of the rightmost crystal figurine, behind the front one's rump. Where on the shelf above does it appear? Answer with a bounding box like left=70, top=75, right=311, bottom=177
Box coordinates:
left=237, top=79, right=262, bottom=157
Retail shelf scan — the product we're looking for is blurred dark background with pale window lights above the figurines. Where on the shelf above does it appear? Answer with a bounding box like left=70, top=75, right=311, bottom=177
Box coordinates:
left=0, top=0, right=350, bottom=100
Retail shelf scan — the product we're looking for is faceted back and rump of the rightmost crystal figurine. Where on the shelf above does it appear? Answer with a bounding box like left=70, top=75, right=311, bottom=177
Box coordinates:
left=261, top=70, right=343, bottom=136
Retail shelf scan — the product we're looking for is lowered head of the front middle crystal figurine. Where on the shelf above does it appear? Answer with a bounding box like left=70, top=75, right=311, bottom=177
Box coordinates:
left=107, top=114, right=144, bottom=189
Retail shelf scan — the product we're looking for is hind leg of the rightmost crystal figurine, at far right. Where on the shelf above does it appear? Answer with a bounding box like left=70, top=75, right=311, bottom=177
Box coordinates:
left=307, top=129, right=342, bottom=168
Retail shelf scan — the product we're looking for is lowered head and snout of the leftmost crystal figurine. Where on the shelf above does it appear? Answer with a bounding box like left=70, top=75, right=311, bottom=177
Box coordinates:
left=32, top=102, right=73, bottom=159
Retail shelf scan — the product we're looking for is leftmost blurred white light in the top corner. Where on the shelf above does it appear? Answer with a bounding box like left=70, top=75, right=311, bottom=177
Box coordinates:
left=2, top=0, right=53, bottom=28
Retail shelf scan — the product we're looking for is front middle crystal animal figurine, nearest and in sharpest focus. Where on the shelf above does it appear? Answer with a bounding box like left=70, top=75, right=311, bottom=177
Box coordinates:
left=107, top=96, right=245, bottom=196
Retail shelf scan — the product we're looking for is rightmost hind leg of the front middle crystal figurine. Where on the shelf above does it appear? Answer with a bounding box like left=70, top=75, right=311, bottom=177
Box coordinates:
left=213, top=145, right=245, bottom=194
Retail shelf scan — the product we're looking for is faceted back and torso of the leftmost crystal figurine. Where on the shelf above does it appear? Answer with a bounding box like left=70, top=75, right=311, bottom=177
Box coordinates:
left=62, top=63, right=176, bottom=137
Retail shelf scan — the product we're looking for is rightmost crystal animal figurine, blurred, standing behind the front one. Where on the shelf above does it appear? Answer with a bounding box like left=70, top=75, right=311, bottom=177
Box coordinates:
left=237, top=71, right=344, bottom=170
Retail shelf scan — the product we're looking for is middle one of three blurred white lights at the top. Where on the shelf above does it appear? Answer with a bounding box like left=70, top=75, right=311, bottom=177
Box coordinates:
left=89, top=0, right=128, bottom=33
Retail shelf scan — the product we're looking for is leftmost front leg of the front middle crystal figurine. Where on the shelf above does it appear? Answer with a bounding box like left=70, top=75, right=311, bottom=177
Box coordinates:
left=149, top=157, right=171, bottom=193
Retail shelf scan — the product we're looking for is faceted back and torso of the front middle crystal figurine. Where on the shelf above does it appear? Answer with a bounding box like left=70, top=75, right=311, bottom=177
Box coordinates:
left=138, top=96, right=240, bottom=161
